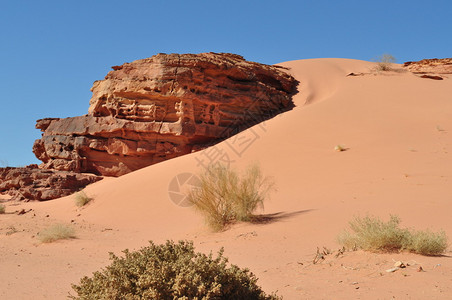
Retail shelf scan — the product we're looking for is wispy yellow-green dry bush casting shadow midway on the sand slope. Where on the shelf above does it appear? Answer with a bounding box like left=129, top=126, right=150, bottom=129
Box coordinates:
left=188, top=164, right=274, bottom=230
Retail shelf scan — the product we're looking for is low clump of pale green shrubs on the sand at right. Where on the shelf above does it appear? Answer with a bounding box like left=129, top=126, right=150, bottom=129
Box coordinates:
left=338, top=216, right=447, bottom=255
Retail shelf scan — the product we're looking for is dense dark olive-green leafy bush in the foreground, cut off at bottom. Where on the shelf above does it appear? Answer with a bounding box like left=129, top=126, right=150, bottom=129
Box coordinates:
left=70, top=241, right=278, bottom=299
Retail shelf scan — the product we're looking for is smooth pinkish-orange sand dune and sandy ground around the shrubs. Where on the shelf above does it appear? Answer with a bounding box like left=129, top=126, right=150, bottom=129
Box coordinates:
left=0, top=59, right=452, bottom=299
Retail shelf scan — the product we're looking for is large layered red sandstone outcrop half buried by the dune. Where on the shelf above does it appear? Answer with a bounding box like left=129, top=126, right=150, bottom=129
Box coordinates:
left=33, top=53, right=298, bottom=176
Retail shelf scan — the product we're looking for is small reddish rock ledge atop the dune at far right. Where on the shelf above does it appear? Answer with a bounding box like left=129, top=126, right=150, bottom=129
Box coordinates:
left=403, top=58, right=452, bottom=76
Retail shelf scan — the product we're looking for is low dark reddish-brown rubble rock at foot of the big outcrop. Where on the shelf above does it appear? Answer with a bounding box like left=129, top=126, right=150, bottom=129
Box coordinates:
left=0, top=165, right=102, bottom=200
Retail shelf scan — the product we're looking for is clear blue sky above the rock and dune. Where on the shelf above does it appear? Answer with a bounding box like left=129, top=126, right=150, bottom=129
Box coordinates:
left=0, top=0, right=452, bottom=166
